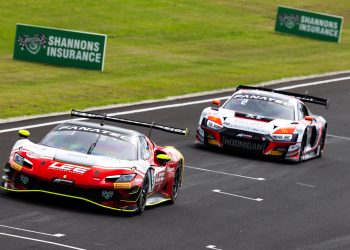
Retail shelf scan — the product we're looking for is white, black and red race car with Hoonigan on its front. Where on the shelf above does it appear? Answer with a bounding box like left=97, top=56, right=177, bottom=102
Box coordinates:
left=195, top=86, right=328, bottom=162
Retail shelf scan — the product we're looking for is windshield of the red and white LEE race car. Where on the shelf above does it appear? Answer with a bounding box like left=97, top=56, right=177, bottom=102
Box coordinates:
left=39, top=127, right=137, bottom=160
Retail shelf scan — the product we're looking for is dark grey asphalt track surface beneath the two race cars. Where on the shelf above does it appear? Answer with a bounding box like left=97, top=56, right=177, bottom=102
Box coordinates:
left=0, top=74, right=350, bottom=250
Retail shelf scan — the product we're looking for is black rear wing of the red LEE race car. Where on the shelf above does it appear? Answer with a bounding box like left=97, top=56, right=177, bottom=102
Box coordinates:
left=70, top=109, right=190, bottom=136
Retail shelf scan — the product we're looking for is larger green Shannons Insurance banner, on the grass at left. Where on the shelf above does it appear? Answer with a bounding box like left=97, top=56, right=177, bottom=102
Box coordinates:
left=13, top=24, right=107, bottom=71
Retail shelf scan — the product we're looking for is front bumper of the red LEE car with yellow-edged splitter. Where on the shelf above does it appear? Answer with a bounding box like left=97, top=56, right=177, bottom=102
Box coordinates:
left=0, top=164, right=141, bottom=212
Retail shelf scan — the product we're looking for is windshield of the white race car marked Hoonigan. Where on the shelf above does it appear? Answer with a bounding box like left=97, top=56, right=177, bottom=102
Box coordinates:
left=223, top=98, right=294, bottom=120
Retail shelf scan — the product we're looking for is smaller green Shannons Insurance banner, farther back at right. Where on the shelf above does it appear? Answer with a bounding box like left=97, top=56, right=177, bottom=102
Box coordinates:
left=275, top=6, right=343, bottom=42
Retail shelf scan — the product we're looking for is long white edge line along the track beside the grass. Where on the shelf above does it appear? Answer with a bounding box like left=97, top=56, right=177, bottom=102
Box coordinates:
left=0, top=73, right=350, bottom=134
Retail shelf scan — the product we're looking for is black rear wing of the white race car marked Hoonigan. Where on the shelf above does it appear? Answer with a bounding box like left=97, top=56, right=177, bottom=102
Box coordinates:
left=236, top=85, right=329, bottom=108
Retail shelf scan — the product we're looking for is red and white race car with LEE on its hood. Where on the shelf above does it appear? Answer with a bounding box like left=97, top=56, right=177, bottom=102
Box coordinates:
left=1, top=110, right=188, bottom=213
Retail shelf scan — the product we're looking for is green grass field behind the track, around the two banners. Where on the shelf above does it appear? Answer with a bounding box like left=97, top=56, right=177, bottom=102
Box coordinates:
left=0, top=0, right=350, bottom=118
